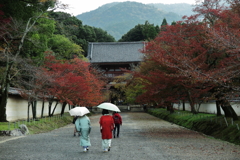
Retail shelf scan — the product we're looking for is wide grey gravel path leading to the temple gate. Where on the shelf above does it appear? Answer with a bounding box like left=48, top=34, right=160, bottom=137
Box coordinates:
left=0, top=113, right=240, bottom=160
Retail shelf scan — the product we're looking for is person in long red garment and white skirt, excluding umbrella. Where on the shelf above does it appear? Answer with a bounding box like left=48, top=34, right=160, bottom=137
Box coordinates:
left=99, top=109, right=114, bottom=152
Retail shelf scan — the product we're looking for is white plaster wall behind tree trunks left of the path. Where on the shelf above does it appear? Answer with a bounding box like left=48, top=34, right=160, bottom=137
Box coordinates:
left=6, top=97, right=69, bottom=121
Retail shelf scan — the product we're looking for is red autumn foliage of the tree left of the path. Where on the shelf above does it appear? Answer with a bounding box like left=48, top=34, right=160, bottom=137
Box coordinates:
left=39, top=56, right=103, bottom=106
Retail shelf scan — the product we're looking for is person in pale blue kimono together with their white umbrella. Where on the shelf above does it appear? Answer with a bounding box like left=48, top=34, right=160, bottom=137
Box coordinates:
left=69, top=107, right=91, bottom=152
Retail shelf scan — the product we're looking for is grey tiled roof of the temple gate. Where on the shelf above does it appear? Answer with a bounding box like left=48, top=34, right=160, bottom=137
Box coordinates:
left=87, top=42, right=144, bottom=63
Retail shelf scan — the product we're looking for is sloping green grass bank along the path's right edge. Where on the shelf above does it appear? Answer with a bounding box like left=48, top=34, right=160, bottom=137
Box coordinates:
left=148, top=109, right=240, bottom=145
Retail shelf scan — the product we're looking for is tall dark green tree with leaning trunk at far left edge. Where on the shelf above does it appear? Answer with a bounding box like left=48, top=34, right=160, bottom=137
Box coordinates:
left=0, top=0, right=62, bottom=121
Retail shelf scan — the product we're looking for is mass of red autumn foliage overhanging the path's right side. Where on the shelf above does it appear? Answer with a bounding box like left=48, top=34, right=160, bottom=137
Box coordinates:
left=130, top=0, right=240, bottom=117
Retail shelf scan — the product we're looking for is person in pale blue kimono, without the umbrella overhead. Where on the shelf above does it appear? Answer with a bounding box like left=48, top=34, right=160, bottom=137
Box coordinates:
left=75, top=115, right=91, bottom=152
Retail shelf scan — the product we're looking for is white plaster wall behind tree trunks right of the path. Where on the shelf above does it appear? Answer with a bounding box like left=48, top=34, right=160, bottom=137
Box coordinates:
left=173, top=102, right=240, bottom=116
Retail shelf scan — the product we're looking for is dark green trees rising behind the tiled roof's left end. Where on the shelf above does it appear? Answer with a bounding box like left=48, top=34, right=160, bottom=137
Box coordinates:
left=49, top=12, right=115, bottom=55
